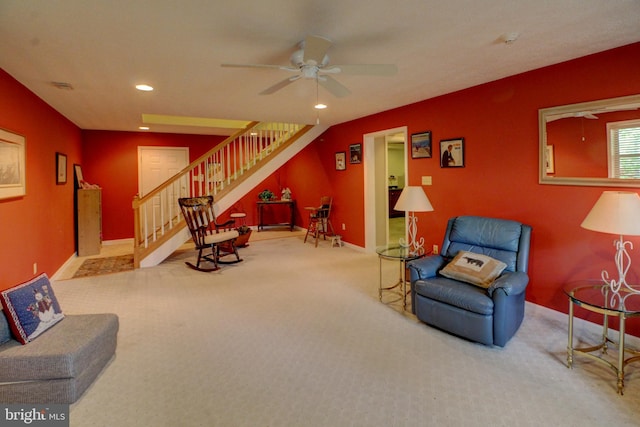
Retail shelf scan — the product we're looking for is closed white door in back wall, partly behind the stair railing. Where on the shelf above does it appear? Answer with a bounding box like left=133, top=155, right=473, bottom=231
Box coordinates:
left=138, top=147, right=189, bottom=232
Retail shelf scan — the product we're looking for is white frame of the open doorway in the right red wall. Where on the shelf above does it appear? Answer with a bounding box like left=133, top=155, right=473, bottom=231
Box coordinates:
left=362, top=126, right=409, bottom=252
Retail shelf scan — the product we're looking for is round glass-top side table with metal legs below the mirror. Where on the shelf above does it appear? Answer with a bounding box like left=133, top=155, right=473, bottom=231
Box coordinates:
left=564, top=280, right=640, bottom=395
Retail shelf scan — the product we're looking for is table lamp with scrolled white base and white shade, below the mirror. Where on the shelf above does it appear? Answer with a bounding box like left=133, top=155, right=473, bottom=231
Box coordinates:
left=581, top=191, right=640, bottom=293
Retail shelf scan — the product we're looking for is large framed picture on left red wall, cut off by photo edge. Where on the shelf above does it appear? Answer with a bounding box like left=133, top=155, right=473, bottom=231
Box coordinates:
left=0, top=129, right=27, bottom=199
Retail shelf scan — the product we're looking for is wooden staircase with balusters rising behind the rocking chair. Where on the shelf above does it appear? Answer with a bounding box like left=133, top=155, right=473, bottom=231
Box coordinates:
left=133, top=122, right=327, bottom=268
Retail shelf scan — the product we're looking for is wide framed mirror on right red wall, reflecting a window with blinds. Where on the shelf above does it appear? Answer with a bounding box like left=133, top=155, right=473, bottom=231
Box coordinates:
left=538, top=95, right=640, bottom=187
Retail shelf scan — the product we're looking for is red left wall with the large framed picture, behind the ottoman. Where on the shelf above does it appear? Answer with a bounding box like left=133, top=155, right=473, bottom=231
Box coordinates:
left=0, top=69, right=81, bottom=289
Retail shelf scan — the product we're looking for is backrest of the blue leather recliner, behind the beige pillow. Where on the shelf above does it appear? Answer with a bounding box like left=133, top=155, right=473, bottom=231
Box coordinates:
left=442, top=216, right=531, bottom=273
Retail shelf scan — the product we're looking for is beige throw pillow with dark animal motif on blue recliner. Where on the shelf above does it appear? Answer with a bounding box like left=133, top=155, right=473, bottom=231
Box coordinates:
left=440, top=251, right=507, bottom=288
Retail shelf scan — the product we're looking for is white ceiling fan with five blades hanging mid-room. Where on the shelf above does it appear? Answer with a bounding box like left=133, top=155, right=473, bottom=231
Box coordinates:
left=221, top=36, right=398, bottom=98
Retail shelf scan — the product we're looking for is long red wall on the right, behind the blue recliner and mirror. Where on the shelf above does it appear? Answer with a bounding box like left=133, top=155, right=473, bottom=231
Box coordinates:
left=287, top=43, right=640, bottom=334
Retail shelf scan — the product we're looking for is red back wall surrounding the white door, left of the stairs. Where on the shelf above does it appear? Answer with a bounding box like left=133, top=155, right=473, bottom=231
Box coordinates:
left=82, top=130, right=226, bottom=240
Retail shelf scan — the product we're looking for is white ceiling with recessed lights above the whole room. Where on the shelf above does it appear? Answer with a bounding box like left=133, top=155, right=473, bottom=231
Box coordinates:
left=0, top=0, right=640, bottom=134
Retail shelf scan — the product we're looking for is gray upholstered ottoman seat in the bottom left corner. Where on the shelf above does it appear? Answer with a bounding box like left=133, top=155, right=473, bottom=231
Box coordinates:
left=0, top=311, right=119, bottom=403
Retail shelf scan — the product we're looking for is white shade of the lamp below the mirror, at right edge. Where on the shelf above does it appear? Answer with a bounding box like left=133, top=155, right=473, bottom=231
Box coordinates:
left=580, top=191, right=640, bottom=236
